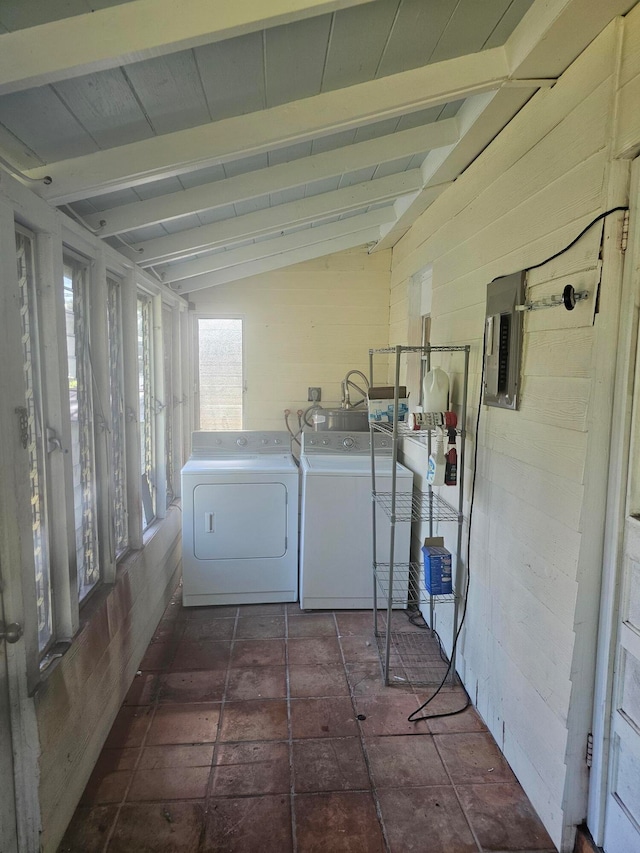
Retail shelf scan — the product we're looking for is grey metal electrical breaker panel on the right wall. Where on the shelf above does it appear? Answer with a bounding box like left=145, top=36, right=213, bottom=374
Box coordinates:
left=484, top=272, right=525, bottom=409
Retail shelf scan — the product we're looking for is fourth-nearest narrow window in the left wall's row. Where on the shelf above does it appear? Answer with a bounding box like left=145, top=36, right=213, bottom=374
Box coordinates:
left=137, top=294, right=156, bottom=529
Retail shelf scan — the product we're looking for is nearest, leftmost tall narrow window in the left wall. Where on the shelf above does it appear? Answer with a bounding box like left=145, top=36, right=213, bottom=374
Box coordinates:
left=16, top=229, right=55, bottom=655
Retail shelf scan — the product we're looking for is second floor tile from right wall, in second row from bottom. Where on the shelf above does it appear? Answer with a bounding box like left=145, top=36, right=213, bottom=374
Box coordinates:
left=365, top=735, right=450, bottom=788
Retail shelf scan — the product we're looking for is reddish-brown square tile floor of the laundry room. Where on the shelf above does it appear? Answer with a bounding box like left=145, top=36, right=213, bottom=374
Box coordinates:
left=59, top=590, right=555, bottom=853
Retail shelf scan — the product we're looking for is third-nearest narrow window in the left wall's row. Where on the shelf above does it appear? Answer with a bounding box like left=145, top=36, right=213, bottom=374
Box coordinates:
left=107, top=276, right=129, bottom=557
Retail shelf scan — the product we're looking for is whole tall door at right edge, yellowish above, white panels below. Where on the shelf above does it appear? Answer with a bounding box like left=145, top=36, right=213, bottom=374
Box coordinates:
left=588, top=168, right=640, bottom=853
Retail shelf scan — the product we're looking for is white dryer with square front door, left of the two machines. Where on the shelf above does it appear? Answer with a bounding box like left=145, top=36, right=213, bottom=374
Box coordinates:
left=182, top=430, right=299, bottom=607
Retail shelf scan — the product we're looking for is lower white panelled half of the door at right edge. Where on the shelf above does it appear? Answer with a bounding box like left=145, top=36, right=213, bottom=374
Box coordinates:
left=604, top=516, right=640, bottom=853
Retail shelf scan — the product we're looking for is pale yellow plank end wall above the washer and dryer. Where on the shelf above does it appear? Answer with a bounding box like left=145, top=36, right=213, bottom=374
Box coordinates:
left=191, top=247, right=391, bottom=429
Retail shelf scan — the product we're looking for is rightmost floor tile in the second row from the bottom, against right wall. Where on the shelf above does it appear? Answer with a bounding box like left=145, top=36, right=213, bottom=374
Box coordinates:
left=433, top=732, right=515, bottom=785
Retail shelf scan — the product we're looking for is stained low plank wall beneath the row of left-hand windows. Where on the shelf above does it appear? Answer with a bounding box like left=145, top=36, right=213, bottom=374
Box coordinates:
left=36, top=507, right=182, bottom=853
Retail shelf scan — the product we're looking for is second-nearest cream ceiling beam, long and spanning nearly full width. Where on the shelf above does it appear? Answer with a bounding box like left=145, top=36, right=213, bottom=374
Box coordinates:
left=28, top=47, right=507, bottom=204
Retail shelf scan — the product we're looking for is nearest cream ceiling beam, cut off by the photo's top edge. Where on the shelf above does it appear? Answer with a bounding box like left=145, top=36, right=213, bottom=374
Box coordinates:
left=0, top=0, right=372, bottom=95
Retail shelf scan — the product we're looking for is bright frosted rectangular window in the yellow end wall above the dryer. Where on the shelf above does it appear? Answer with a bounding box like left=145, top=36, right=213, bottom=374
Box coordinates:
left=198, top=317, right=244, bottom=430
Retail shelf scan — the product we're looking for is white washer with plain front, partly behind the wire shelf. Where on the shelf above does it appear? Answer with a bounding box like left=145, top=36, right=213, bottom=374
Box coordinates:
left=300, top=431, right=413, bottom=610
